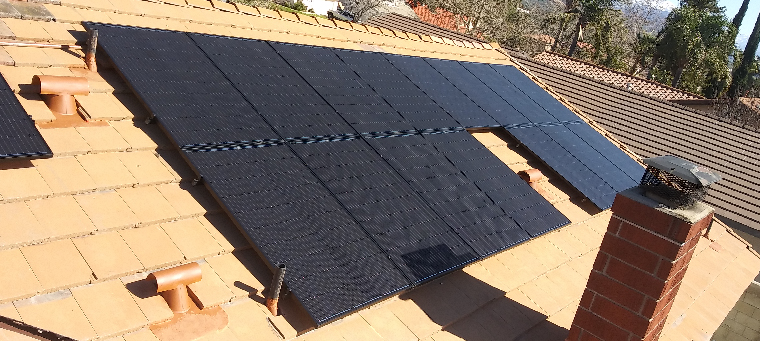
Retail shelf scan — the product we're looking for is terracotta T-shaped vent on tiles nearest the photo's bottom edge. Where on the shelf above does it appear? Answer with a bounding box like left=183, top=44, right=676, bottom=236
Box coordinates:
left=148, top=263, right=202, bottom=314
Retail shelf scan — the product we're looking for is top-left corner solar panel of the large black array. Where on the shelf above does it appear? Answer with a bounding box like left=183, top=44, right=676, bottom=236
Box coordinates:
left=98, top=25, right=278, bottom=146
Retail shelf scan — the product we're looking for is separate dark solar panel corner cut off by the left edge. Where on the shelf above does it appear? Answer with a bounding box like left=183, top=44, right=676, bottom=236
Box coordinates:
left=0, top=76, right=53, bottom=159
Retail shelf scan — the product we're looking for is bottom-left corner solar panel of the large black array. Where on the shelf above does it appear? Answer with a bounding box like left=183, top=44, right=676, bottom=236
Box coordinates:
left=187, top=146, right=409, bottom=323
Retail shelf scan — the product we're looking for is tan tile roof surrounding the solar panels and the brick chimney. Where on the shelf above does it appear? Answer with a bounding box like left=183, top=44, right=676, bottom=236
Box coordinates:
left=0, top=0, right=760, bottom=341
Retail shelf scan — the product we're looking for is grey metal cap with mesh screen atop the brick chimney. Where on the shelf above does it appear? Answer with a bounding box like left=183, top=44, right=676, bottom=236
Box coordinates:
left=640, top=155, right=721, bottom=209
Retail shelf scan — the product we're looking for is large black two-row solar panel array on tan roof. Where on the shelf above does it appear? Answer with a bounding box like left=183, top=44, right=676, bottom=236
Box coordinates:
left=89, top=24, right=635, bottom=324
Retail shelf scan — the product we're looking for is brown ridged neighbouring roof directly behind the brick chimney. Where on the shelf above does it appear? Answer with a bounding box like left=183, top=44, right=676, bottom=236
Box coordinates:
left=519, top=59, right=760, bottom=229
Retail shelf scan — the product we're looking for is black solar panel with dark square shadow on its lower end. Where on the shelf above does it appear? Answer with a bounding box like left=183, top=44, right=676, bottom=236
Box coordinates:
left=293, top=138, right=478, bottom=284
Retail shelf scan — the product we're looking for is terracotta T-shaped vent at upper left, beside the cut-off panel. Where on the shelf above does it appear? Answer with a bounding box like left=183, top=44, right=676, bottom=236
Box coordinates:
left=32, top=75, right=90, bottom=115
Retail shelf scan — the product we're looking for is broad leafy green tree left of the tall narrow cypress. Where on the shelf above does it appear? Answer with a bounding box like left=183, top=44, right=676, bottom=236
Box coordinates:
left=651, top=0, right=736, bottom=96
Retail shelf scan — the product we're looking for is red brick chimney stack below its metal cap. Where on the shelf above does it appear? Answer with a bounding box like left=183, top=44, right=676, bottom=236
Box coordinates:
left=567, top=187, right=713, bottom=341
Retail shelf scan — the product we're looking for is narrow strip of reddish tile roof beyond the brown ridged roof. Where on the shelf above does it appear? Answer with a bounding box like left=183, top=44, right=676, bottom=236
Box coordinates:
left=533, top=52, right=704, bottom=100
